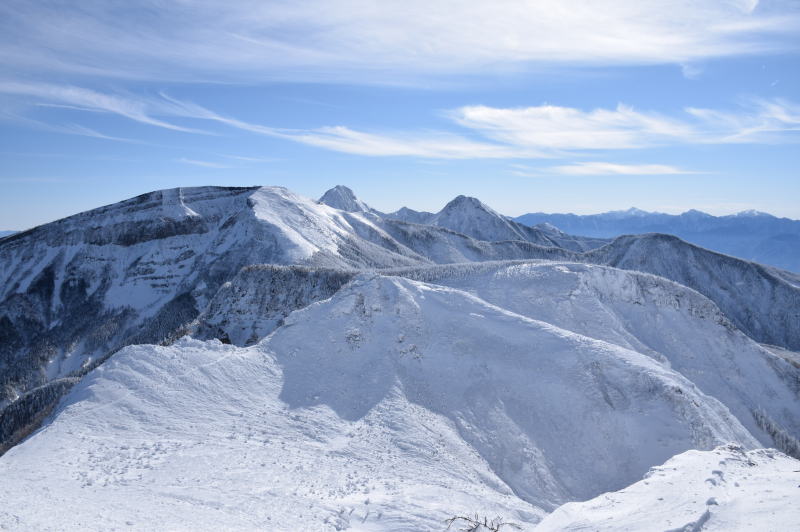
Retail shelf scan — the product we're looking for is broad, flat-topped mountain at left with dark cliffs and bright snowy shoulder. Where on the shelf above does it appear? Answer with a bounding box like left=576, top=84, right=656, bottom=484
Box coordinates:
left=0, top=187, right=438, bottom=444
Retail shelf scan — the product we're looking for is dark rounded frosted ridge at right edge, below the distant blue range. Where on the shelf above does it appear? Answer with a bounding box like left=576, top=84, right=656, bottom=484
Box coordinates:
left=584, top=234, right=800, bottom=351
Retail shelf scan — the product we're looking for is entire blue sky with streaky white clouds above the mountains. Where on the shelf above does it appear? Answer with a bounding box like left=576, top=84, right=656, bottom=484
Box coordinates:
left=0, top=0, right=800, bottom=229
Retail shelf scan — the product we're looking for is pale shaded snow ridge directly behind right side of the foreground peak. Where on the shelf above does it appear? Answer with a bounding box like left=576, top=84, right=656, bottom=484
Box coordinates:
left=407, top=263, right=800, bottom=456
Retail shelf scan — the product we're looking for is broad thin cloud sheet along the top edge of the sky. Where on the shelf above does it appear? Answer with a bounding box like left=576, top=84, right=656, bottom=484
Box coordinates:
left=0, top=0, right=800, bottom=83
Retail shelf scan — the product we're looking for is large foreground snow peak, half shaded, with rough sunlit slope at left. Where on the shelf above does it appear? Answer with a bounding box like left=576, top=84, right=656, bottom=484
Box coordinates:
left=0, top=274, right=757, bottom=531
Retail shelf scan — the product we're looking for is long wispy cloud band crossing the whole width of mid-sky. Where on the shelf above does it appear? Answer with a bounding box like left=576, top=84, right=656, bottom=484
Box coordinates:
left=6, top=81, right=800, bottom=160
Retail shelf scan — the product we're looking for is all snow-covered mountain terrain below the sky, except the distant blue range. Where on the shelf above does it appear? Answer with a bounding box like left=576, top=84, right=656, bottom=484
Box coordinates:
left=0, top=186, right=800, bottom=531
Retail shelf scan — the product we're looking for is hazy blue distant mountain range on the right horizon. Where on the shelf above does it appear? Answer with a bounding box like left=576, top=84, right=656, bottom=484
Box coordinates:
left=514, top=208, right=800, bottom=272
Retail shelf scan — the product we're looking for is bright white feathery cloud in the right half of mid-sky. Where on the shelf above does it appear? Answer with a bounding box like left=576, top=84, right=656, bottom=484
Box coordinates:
left=448, top=99, right=800, bottom=155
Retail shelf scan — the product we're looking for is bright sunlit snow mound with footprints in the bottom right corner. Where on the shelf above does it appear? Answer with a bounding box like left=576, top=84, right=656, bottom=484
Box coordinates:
left=535, top=445, right=800, bottom=532
